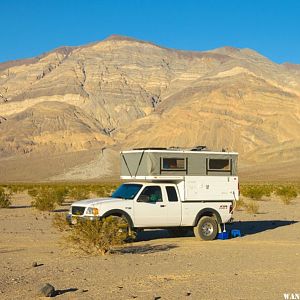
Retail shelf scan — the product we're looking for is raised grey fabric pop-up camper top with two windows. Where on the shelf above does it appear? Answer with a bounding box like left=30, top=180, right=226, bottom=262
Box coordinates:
left=120, top=146, right=238, bottom=181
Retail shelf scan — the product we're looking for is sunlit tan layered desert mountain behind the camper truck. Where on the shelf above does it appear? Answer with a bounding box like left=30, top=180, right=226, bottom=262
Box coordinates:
left=0, top=36, right=300, bottom=181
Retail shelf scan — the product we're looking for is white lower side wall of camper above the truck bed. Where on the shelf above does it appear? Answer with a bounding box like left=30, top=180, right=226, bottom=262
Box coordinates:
left=183, top=176, right=239, bottom=201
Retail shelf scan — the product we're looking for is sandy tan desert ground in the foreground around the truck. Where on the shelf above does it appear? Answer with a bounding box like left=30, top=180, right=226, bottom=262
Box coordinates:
left=0, top=194, right=300, bottom=299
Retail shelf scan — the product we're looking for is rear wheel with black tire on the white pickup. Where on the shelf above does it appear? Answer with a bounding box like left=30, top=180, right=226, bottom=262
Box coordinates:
left=194, top=216, right=218, bottom=241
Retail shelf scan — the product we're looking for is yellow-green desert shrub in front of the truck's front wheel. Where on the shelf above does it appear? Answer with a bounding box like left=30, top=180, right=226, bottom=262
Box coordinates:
left=53, top=215, right=127, bottom=255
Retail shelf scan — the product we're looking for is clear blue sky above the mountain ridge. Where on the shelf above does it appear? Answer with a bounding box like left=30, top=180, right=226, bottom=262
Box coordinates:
left=0, top=0, right=300, bottom=64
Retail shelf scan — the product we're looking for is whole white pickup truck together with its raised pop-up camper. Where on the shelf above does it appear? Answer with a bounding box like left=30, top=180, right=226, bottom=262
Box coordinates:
left=68, top=146, right=239, bottom=240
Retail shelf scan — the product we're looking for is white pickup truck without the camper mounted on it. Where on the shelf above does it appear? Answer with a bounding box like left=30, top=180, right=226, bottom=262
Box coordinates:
left=68, top=180, right=238, bottom=240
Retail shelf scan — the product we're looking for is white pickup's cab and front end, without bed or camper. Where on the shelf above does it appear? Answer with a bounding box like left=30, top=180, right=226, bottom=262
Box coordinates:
left=70, top=182, right=182, bottom=228
